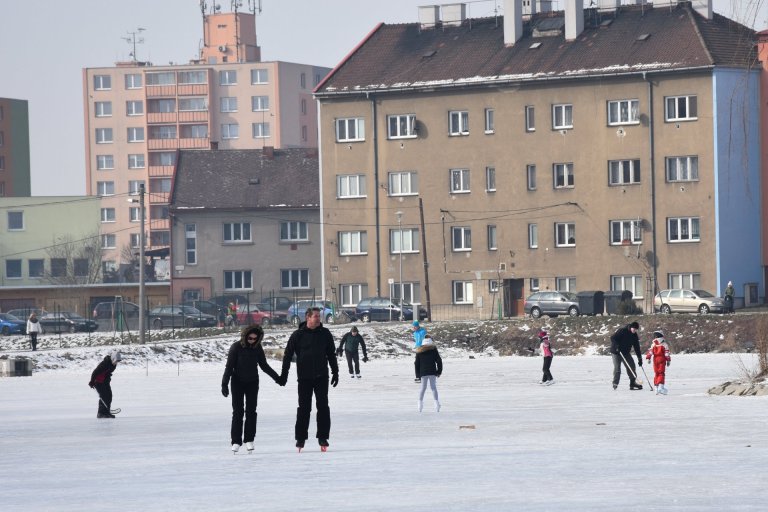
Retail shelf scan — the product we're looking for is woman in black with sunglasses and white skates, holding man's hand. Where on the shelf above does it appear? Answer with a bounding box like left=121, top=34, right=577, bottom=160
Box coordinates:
left=221, top=325, right=283, bottom=453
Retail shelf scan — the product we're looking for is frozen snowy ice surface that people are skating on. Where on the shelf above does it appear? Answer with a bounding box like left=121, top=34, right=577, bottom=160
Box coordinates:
left=0, top=343, right=768, bottom=512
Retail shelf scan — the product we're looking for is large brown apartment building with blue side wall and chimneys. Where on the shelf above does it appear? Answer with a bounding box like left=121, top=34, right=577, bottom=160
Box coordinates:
left=315, top=0, right=764, bottom=318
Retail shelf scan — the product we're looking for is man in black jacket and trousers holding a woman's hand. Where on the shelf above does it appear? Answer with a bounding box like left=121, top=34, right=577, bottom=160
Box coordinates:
left=280, top=308, right=339, bottom=451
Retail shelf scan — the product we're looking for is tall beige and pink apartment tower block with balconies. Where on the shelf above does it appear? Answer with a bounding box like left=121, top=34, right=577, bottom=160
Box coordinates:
left=83, top=8, right=330, bottom=278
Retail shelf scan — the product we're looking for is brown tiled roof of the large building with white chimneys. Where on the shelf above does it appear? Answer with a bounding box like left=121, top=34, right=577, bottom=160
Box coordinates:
left=316, top=3, right=757, bottom=97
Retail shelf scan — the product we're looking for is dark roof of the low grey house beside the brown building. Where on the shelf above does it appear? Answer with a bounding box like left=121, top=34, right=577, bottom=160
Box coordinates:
left=170, top=148, right=320, bottom=210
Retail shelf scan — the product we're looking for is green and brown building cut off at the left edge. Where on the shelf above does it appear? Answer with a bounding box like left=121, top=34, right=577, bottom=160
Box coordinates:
left=0, top=98, right=32, bottom=197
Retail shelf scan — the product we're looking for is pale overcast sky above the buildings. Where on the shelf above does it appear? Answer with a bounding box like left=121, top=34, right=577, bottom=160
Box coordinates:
left=0, top=0, right=768, bottom=195
